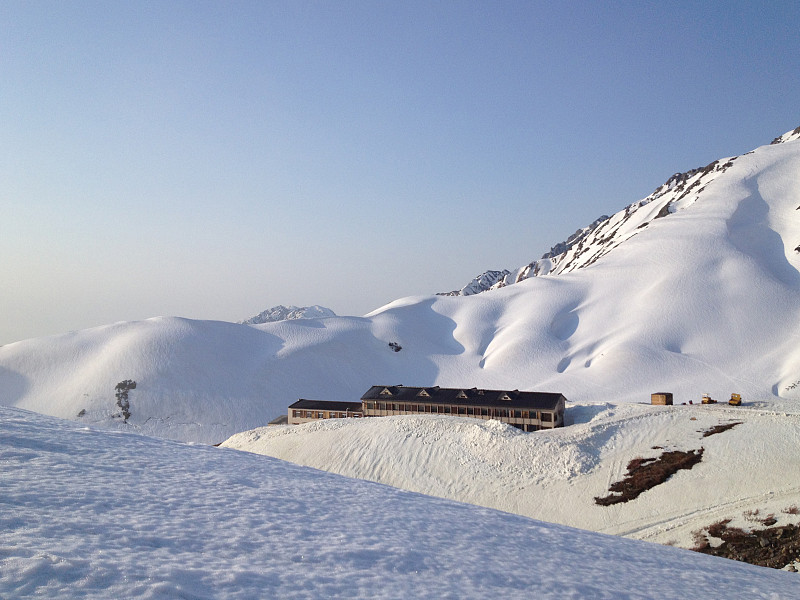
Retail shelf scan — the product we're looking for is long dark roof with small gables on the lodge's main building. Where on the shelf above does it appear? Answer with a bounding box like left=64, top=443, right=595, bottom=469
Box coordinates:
left=361, top=385, right=566, bottom=410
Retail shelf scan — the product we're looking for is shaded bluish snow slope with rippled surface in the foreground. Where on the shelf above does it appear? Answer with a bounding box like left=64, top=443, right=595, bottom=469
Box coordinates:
left=0, top=407, right=797, bottom=600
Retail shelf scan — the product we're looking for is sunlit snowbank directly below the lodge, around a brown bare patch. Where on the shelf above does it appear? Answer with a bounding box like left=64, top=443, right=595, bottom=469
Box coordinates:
left=223, top=402, right=800, bottom=560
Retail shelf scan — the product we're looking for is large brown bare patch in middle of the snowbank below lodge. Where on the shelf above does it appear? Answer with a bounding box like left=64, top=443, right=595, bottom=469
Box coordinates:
left=594, top=448, right=703, bottom=506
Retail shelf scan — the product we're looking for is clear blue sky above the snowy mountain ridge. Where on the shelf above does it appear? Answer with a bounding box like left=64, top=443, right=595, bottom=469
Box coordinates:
left=0, top=0, right=800, bottom=344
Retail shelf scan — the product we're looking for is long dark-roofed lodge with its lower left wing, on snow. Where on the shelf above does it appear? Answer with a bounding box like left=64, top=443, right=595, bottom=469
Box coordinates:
left=288, top=385, right=566, bottom=431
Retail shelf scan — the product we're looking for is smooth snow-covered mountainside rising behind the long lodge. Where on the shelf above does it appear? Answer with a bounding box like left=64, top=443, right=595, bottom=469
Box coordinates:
left=0, top=132, right=800, bottom=442
